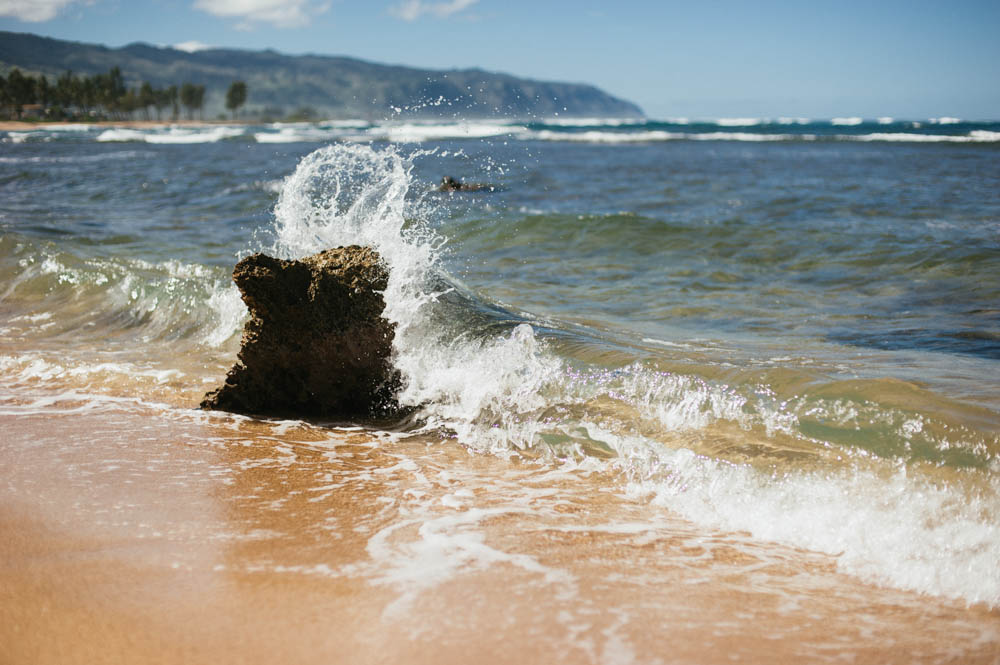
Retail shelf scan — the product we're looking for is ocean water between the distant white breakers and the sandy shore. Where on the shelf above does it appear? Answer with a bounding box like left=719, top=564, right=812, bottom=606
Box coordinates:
left=0, top=128, right=1000, bottom=605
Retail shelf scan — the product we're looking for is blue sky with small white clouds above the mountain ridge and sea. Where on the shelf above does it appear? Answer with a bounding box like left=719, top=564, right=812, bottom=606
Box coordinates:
left=0, top=0, right=1000, bottom=119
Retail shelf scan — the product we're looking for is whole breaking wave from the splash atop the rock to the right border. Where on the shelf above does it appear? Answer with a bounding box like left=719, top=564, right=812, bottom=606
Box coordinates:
left=258, top=144, right=1000, bottom=604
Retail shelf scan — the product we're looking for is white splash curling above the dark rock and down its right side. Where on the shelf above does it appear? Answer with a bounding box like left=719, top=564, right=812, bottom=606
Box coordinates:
left=273, top=144, right=559, bottom=452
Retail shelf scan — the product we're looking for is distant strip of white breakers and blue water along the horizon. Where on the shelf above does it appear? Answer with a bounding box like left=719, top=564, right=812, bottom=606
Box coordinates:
left=7, top=117, right=1000, bottom=144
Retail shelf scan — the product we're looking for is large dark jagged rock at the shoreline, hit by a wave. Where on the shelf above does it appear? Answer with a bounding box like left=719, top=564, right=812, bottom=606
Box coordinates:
left=201, top=245, right=400, bottom=422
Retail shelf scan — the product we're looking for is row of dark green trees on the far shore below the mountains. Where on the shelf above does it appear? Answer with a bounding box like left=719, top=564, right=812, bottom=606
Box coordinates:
left=0, top=67, right=247, bottom=120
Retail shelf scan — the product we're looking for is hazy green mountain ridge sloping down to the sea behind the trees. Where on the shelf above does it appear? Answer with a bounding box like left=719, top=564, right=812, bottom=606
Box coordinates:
left=0, top=32, right=643, bottom=118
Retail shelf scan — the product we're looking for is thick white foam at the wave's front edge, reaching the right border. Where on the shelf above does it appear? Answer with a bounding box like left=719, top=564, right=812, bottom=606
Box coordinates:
left=616, top=430, right=1000, bottom=605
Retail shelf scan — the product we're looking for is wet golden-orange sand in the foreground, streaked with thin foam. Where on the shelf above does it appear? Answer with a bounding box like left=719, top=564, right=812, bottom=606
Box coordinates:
left=0, top=402, right=1000, bottom=664
